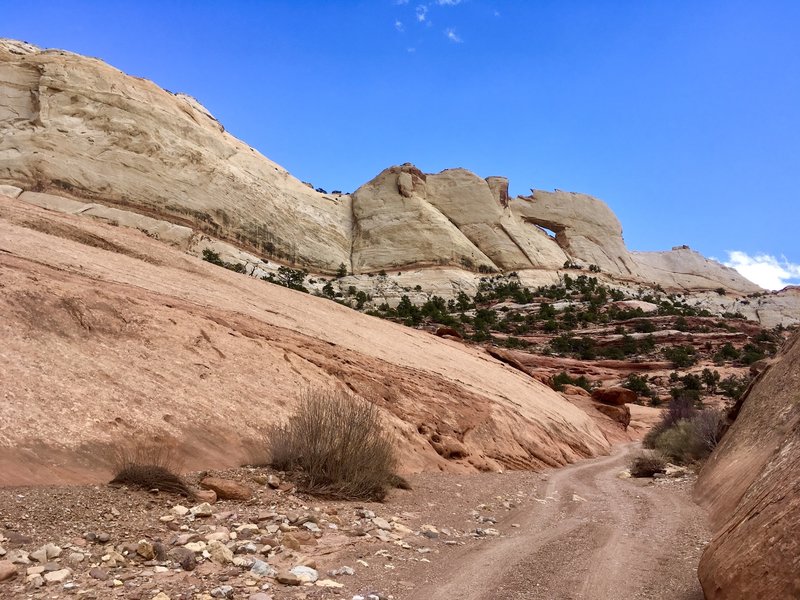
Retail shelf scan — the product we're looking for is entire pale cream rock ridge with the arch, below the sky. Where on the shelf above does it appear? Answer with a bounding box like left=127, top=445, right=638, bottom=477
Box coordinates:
left=0, top=40, right=783, bottom=302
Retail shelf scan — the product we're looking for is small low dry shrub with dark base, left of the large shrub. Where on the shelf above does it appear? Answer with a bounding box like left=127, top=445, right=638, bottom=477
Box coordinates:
left=109, top=444, right=193, bottom=497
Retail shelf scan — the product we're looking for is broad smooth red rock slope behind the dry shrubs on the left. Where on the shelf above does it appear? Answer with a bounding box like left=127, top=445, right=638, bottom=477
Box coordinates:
left=0, top=196, right=609, bottom=485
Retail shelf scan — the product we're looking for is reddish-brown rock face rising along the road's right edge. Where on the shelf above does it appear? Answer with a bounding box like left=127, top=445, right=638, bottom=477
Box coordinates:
left=696, top=334, right=800, bottom=600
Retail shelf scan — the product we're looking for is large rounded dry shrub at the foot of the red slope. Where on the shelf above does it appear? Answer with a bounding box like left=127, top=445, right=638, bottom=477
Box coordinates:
left=268, top=389, right=397, bottom=500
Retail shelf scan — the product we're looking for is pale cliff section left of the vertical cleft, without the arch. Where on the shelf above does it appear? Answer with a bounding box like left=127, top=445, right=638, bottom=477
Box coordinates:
left=0, top=40, right=352, bottom=270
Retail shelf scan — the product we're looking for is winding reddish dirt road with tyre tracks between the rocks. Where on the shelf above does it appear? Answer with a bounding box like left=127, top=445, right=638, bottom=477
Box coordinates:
left=408, top=444, right=707, bottom=600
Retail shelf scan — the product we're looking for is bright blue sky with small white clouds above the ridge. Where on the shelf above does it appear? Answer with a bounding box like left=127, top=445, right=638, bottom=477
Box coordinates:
left=0, top=0, right=800, bottom=287
